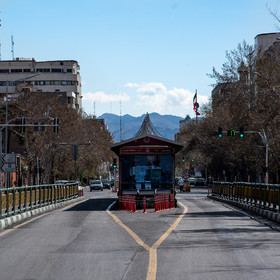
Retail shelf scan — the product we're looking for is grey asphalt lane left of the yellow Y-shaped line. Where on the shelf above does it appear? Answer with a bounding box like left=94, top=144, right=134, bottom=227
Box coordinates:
left=0, top=188, right=148, bottom=280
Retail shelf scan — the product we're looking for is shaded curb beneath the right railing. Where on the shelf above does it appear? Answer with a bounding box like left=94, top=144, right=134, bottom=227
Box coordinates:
left=207, top=195, right=280, bottom=223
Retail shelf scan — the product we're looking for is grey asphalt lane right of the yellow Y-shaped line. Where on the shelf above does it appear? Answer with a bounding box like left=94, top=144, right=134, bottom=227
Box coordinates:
left=158, top=188, right=280, bottom=280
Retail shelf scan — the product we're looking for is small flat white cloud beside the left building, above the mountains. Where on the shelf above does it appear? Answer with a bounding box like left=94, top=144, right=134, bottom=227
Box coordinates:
left=83, top=91, right=130, bottom=104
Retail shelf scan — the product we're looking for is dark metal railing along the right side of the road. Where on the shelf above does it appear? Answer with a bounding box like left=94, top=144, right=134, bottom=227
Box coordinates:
left=212, top=181, right=280, bottom=212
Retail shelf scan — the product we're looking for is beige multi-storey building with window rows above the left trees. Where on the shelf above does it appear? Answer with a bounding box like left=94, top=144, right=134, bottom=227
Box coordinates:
left=0, top=58, right=82, bottom=112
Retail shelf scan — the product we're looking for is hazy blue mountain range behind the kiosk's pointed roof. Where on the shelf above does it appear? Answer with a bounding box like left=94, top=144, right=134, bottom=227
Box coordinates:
left=98, top=113, right=183, bottom=142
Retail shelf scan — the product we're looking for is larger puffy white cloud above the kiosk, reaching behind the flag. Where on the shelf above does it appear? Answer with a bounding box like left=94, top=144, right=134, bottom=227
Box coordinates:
left=132, top=82, right=209, bottom=116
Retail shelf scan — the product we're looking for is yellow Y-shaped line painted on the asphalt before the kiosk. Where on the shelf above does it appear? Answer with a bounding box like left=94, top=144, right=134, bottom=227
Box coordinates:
left=107, top=202, right=188, bottom=280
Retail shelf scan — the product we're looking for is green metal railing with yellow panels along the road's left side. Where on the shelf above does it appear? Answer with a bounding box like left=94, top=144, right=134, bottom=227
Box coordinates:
left=0, top=183, right=79, bottom=218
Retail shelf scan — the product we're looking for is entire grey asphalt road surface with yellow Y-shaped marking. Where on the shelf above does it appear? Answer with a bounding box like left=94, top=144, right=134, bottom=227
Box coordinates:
left=0, top=187, right=280, bottom=280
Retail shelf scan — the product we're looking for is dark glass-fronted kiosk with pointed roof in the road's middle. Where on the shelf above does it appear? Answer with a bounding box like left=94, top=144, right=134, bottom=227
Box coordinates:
left=111, top=113, right=183, bottom=208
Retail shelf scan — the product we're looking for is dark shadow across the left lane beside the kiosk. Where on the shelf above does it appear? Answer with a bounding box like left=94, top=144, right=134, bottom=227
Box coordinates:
left=65, top=198, right=116, bottom=212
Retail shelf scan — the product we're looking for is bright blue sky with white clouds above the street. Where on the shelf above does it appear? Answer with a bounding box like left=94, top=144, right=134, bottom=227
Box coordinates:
left=0, top=0, right=280, bottom=117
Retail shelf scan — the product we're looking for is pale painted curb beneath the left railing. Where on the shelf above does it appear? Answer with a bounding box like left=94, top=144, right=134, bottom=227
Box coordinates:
left=0, top=197, right=80, bottom=231
